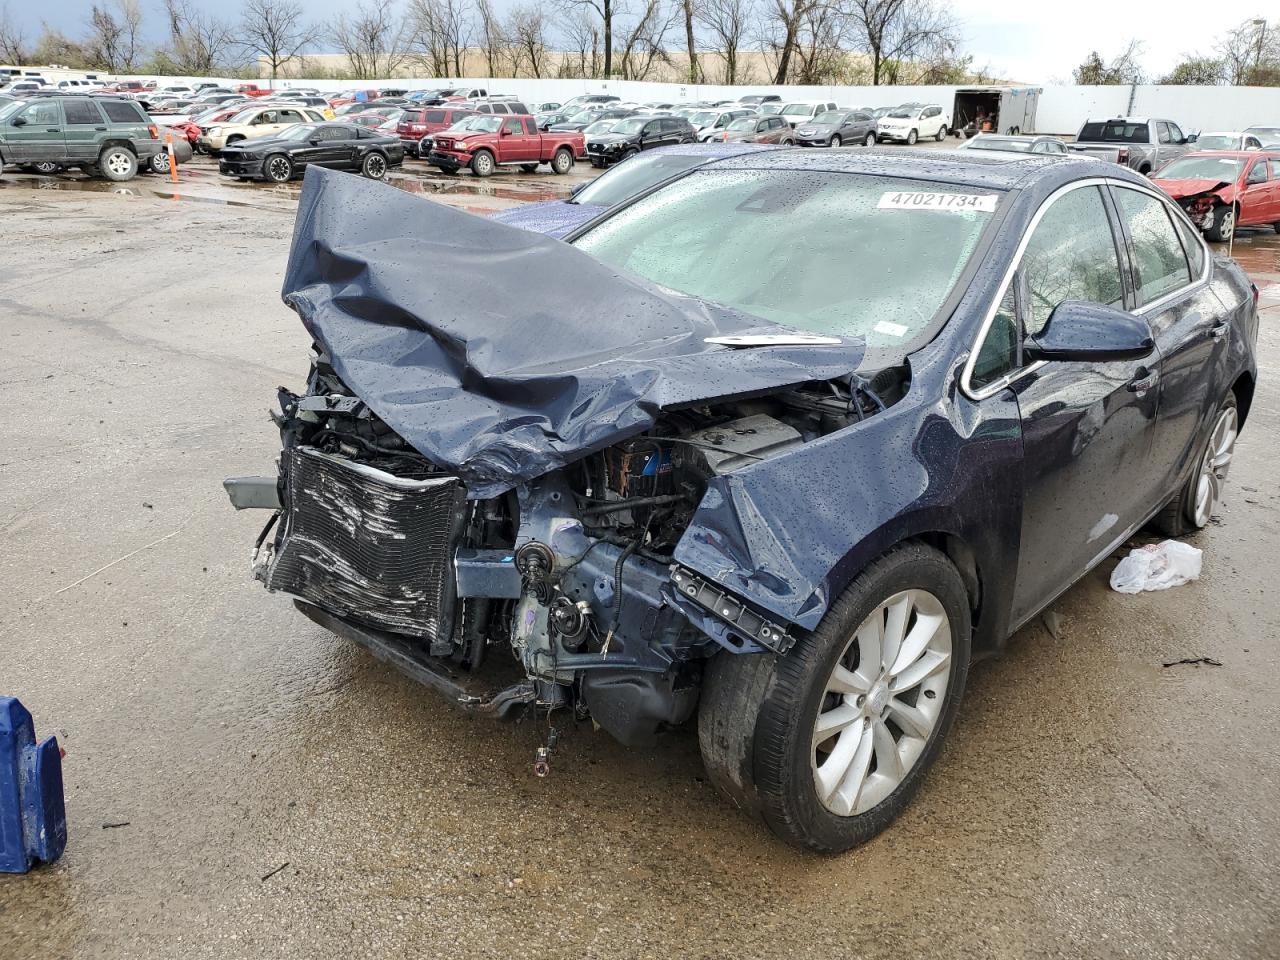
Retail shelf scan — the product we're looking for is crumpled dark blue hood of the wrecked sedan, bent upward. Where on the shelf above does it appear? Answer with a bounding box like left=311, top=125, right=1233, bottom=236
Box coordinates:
left=283, top=166, right=864, bottom=498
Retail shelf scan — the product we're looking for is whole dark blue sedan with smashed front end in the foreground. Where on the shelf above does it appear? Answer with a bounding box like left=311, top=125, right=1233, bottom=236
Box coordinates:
left=228, top=151, right=1258, bottom=851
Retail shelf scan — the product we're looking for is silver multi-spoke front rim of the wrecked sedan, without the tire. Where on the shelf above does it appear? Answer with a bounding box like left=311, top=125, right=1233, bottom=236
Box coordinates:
left=810, top=590, right=951, bottom=817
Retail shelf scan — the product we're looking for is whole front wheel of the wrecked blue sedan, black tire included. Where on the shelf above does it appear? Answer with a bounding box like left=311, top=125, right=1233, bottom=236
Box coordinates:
left=698, top=543, right=970, bottom=854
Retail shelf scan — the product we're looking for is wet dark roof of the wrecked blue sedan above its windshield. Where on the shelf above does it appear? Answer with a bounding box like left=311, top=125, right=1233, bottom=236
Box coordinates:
left=716, top=147, right=1121, bottom=189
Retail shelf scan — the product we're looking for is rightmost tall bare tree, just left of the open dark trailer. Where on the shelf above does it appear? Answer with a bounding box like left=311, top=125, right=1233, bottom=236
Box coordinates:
left=845, top=0, right=959, bottom=86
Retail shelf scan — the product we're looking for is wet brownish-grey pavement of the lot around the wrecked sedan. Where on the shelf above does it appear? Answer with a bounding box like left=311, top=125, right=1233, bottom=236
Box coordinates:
left=0, top=164, right=1280, bottom=960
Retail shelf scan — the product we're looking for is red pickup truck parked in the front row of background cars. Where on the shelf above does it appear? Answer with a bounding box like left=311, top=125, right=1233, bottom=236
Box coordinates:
left=426, top=114, right=582, bottom=177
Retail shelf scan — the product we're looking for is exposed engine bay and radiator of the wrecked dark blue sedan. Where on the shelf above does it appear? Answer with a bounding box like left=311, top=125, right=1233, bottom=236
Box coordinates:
left=241, top=347, right=909, bottom=744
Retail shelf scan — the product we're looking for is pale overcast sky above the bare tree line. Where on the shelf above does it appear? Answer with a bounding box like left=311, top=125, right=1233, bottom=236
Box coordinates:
left=12, top=0, right=1276, bottom=83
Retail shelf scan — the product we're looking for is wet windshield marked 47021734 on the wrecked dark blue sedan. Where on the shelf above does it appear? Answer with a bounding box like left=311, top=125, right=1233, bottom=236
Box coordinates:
left=575, top=168, right=1001, bottom=357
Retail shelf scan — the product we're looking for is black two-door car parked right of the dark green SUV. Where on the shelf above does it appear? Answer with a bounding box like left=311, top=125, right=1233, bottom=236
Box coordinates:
left=218, top=123, right=404, bottom=183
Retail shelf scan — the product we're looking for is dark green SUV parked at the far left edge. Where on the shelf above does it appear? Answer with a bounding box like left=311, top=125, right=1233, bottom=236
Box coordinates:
left=0, top=96, right=165, bottom=180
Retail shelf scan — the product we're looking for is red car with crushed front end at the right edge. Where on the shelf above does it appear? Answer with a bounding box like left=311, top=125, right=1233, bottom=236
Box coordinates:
left=1151, top=150, right=1280, bottom=242
